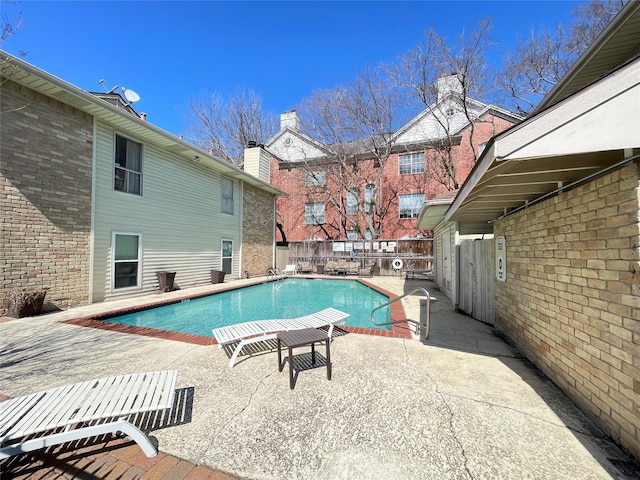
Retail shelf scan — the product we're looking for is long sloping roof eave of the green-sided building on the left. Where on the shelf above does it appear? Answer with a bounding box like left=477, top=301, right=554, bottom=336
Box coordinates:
left=0, top=50, right=283, bottom=195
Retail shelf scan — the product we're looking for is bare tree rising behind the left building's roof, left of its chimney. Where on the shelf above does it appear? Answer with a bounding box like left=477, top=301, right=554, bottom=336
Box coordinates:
left=182, top=88, right=277, bottom=167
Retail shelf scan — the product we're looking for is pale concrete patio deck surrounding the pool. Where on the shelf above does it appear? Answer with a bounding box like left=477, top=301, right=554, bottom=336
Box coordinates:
left=0, top=277, right=639, bottom=480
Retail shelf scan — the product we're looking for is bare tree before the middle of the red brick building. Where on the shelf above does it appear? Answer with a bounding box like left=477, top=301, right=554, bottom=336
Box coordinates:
left=302, top=68, right=398, bottom=238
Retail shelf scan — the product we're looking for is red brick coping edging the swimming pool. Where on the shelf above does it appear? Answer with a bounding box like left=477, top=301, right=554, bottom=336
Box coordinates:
left=61, top=276, right=412, bottom=345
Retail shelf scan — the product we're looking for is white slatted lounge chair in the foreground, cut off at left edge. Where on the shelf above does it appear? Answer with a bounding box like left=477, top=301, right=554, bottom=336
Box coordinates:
left=0, top=370, right=178, bottom=459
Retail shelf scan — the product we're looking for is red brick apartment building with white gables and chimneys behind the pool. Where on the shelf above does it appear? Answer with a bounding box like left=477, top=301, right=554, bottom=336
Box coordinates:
left=266, top=76, right=521, bottom=241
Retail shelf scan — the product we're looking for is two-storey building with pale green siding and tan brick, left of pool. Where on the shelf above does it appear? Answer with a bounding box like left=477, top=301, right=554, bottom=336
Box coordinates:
left=0, top=52, right=282, bottom=309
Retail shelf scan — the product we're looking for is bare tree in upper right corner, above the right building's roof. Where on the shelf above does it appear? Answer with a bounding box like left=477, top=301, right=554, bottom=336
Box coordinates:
left=496, top=0, right=627, bottom=115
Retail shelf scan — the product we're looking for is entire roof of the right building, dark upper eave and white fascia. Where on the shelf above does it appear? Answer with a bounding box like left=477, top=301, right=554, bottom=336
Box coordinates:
left=418, top=1, right=640, bottom=228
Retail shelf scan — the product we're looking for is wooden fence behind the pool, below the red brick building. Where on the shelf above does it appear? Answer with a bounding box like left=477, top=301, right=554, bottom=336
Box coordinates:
left=289, top=238, right=433, bottom=275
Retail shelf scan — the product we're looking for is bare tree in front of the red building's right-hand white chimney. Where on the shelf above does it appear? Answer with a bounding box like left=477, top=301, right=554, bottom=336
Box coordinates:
left=386, top=18, right=492, bottom=190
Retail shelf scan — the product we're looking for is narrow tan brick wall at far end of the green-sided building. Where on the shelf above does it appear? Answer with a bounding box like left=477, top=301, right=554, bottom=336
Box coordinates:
left=240, top=183, right=275, bottom=277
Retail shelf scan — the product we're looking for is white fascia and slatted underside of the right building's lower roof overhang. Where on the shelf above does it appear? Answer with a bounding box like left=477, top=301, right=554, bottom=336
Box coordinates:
left=445, top=59, right=640, bottom=226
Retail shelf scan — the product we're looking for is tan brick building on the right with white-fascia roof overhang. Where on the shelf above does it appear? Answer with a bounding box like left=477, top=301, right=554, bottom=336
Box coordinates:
left=421, top=2, right=640, bottom=460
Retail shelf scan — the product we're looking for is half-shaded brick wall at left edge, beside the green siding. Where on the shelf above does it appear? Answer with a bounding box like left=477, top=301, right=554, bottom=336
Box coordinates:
left=0, top=79, right=93, bottom=308
